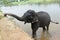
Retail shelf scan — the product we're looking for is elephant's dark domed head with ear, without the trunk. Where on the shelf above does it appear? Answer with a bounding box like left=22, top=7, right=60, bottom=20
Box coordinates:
left=22, top=10, right=38, bottom=23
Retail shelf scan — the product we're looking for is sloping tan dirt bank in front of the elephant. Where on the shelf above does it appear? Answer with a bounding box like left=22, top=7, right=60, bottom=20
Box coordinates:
left=0, top=18, right=33, bottom=40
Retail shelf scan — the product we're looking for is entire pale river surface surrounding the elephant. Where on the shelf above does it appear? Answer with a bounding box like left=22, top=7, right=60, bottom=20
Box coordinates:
left=1, top=4, right=60, bottom=40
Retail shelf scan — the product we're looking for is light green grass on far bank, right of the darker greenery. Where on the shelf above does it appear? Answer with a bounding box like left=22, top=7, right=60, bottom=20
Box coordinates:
left=12, top=0, right=60, bottom=4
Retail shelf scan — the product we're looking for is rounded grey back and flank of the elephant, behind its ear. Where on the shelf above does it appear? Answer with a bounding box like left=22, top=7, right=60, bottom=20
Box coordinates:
left=37, top=11, right=51, bottom=24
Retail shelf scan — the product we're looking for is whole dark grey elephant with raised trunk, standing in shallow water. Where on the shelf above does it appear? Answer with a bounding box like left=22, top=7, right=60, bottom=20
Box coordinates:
left=4, top=10, right=58, bottom=37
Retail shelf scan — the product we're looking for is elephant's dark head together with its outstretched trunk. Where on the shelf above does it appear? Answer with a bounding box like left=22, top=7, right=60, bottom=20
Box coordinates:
left=4, top=10, right=38, bottom=23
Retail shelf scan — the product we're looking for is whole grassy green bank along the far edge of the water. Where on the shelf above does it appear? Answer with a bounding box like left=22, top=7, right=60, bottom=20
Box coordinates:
left=3, top=0, right=60, bottom=6
